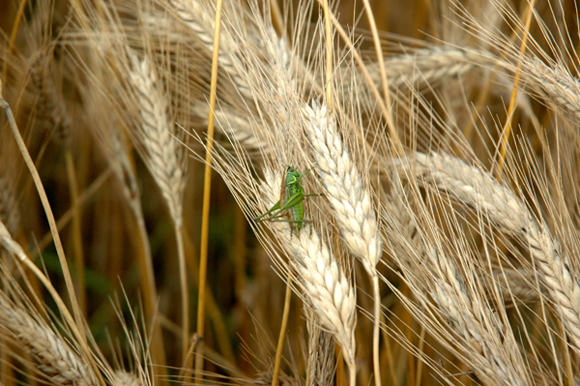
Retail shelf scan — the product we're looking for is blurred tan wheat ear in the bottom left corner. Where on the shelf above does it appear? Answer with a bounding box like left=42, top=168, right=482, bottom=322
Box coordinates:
left=0, top=292, right=99, bottom=386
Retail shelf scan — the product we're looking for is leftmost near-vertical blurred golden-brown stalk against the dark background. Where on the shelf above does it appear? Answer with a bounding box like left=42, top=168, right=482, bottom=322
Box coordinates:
left=65, top=147, right=87, bottom=316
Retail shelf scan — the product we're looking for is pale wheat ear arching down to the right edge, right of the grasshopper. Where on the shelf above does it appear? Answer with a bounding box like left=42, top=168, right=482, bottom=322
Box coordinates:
left=395, top=153, right=580, bottom=351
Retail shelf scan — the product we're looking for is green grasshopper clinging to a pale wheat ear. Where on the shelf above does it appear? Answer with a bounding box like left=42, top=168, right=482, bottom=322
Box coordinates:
left=254, top=166, right=317, bottom=232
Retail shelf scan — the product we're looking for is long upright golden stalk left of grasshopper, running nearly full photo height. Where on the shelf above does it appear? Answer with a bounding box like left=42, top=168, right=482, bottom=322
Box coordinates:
left=195, top=0, right=223, bottom=376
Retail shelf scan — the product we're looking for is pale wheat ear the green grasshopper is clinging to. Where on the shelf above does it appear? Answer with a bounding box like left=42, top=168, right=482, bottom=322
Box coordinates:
left=261, top=169, right=356, bottom=366
